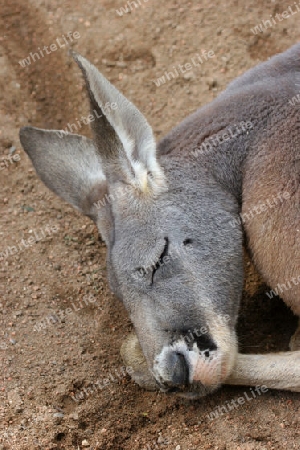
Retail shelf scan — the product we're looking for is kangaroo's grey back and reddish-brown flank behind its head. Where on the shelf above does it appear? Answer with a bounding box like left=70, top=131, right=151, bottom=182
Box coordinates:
left=158, top=44, right=300, bottom=315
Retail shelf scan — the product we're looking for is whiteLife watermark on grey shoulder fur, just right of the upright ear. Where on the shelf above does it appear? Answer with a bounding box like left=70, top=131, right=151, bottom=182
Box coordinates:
left=191, top=120, right=253, bottom=157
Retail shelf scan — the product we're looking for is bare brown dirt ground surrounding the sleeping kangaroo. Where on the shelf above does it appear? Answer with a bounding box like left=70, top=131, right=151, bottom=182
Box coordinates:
left=0, top=0, right=300, bottom=450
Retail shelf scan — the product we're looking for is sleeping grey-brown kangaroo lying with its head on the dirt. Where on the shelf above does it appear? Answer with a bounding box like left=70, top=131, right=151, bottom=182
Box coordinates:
left=20, top=44, right=300, bottom=398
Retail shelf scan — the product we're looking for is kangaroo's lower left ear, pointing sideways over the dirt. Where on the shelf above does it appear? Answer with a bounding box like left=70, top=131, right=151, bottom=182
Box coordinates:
left=20, top=127, right=111, bottom=240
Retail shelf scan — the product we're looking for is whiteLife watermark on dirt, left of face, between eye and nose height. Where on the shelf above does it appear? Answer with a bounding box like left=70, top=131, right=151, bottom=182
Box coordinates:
left=33, top=294, right=101, bottom=332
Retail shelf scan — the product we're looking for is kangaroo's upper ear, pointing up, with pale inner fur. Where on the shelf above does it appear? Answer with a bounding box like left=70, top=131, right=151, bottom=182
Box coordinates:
left=72, top=52, right=166, bottom=195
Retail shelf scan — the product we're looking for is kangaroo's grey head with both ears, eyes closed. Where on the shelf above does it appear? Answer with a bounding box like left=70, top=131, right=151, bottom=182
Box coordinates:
left=20, top=55, right=243, bottom=392
